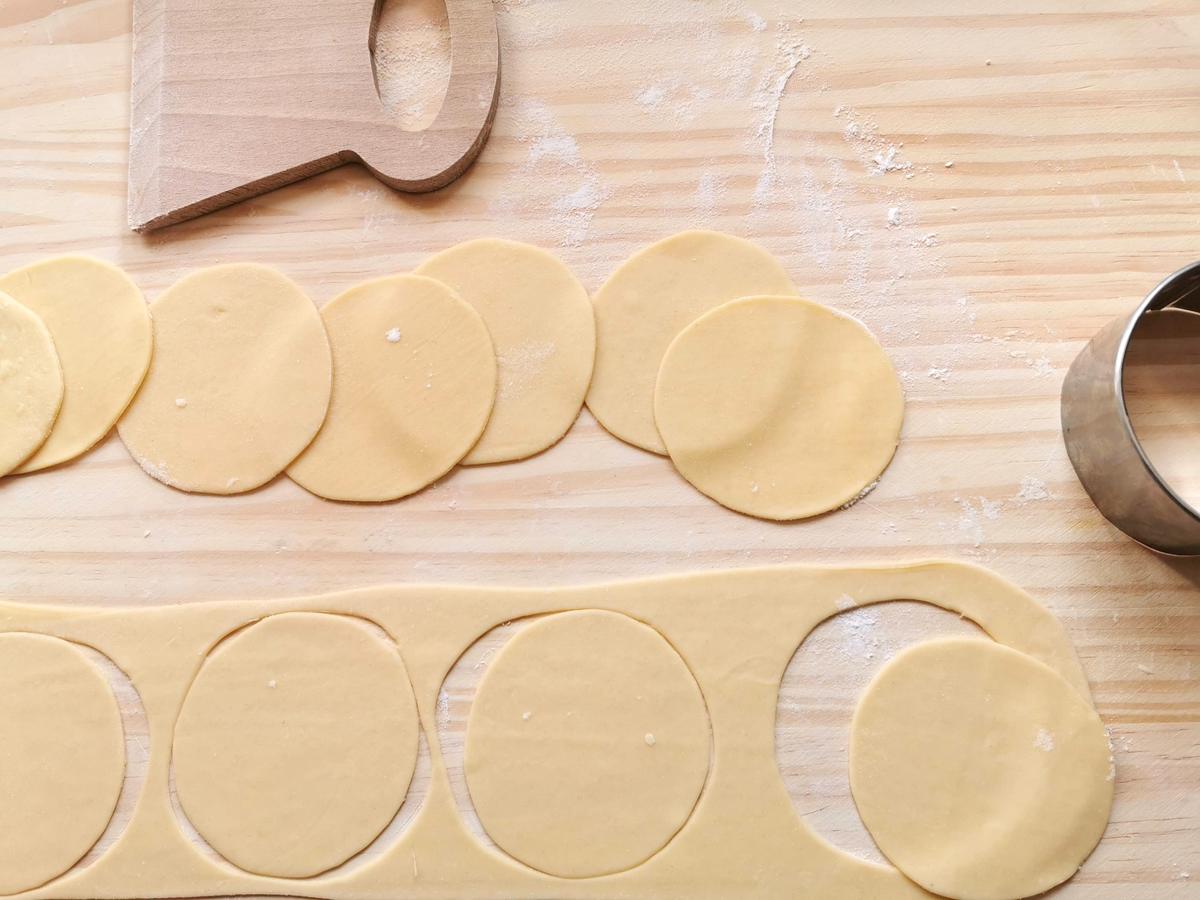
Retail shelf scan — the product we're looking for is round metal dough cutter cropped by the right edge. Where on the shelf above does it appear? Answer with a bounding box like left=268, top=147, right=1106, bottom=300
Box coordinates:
left=1062, top=262, right=1200, bottom=556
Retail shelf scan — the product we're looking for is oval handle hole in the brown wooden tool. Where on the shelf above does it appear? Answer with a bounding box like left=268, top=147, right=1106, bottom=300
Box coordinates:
left=371, top=0, right=450, bottom=131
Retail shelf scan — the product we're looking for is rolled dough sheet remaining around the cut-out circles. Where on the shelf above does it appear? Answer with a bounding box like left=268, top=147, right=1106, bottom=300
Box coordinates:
left=0, top=560, right=1090, bottom=900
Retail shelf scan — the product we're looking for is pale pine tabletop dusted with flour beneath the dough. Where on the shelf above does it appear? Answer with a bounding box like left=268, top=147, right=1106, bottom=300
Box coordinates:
left=0, top=0, right=1200, bottom=900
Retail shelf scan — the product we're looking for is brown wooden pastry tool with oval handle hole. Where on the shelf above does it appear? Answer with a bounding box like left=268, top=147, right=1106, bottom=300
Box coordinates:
left=128, top=0, right=499, bottom=232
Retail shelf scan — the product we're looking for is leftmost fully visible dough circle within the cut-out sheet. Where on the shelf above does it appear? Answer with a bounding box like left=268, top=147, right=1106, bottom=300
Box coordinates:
left=173, top=612, right=418, bottom=878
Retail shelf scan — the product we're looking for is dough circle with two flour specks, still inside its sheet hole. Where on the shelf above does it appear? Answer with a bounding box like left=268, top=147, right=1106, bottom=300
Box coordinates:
left=466, top=610, right=710, bottom=878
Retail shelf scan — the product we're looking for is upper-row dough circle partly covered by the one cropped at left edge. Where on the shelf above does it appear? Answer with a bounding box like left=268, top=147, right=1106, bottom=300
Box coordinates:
left=0, top=257, right=154, bottom=473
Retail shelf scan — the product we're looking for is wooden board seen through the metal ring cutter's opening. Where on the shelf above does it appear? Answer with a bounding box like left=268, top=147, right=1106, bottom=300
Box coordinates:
left=1124, top=310, right=1200, bottom=510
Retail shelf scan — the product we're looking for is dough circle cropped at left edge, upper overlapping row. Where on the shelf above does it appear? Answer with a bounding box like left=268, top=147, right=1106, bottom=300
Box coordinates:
left=0, top=292, right=62, bottom=475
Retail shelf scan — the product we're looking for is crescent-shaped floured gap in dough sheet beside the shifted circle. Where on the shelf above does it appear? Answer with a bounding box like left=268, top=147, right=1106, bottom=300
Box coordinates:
left=775, top=600, right=983, bottom=865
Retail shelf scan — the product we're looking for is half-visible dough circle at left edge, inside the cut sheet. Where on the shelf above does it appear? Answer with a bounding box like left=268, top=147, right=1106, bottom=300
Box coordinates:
left=0, top=632, right=125, bottom=895
